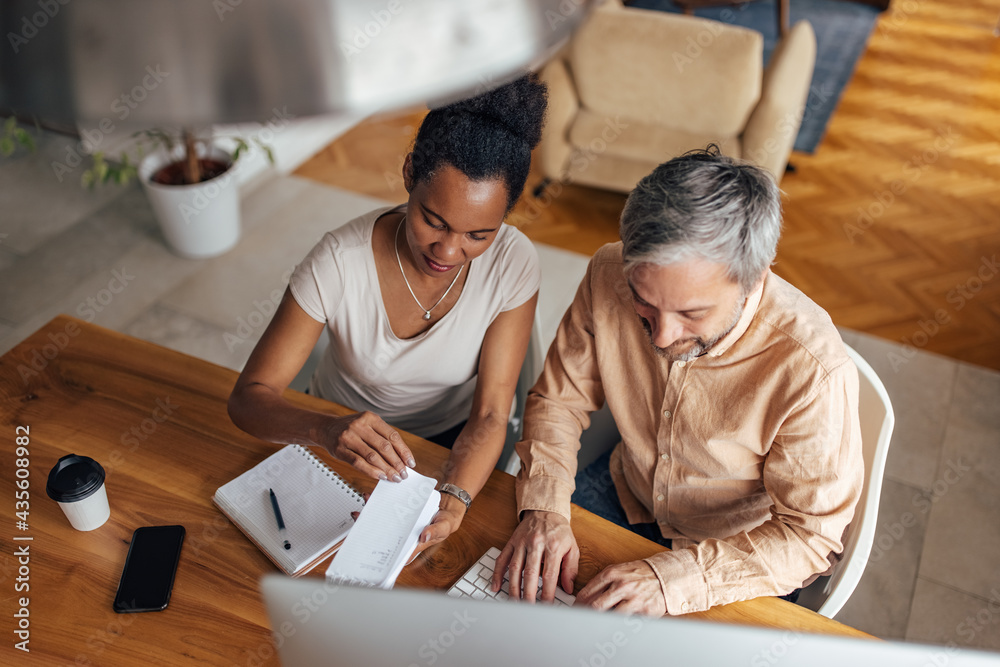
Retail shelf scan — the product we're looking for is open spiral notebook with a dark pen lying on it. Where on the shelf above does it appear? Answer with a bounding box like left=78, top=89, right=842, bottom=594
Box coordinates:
left=212, top=445, right=364, bottom=576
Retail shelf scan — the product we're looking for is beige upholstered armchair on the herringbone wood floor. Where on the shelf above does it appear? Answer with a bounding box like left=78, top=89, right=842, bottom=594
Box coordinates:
left=536, top=3, right=816, bottom=192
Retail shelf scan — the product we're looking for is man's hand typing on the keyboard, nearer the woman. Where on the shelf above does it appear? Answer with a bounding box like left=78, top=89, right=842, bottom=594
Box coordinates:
left=493, top=510, right=580, bottom=602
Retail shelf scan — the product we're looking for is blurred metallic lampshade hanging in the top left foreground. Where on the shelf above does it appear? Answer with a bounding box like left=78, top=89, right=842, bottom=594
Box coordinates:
left=0, top=0, right=594, bottom=127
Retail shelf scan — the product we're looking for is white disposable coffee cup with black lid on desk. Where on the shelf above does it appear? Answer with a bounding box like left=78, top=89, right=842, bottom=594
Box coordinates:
left=45, top=454, right=111, bottom=530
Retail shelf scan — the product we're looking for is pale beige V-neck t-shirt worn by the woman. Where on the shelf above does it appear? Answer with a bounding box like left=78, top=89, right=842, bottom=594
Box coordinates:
left=289, top=207, right=541, bottom=437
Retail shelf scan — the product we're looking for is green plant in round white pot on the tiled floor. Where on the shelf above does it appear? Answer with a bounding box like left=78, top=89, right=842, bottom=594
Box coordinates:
left=82, top=129, right=274, bottom=259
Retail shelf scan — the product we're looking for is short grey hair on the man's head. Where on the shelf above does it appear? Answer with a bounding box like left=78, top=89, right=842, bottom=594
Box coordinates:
left=620, top=144, right=781, bottom=294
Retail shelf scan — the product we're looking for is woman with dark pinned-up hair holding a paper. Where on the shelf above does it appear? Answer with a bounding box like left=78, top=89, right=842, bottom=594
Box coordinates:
left=229, top=75, right=547, bottom=544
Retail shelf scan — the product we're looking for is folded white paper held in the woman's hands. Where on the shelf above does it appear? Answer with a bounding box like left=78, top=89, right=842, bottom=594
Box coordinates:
left=326, top=469, right=441, bottom=588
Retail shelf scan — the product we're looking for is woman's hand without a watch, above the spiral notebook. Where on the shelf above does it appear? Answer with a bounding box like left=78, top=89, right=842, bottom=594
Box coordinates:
left=321, top=412, right=416, bottom=482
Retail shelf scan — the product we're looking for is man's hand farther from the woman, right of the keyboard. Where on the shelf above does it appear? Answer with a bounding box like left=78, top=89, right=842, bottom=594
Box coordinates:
left=575, top=560, right=667, bottom=616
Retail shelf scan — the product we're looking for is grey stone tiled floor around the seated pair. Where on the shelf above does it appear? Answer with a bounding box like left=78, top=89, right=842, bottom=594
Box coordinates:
left=0, top=132, right=1000, bottom=650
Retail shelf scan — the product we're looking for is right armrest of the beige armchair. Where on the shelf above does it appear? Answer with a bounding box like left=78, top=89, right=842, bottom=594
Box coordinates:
left=743, top=21, right=816, bottom=182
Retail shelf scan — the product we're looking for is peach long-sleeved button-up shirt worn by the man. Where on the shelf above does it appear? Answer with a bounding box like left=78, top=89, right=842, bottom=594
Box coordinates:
left=517, top=243, right=864, bottom=614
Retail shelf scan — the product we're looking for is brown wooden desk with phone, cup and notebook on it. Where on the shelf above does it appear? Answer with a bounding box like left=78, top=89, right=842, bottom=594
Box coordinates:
left=0, top=316, right=867, bottom=665
